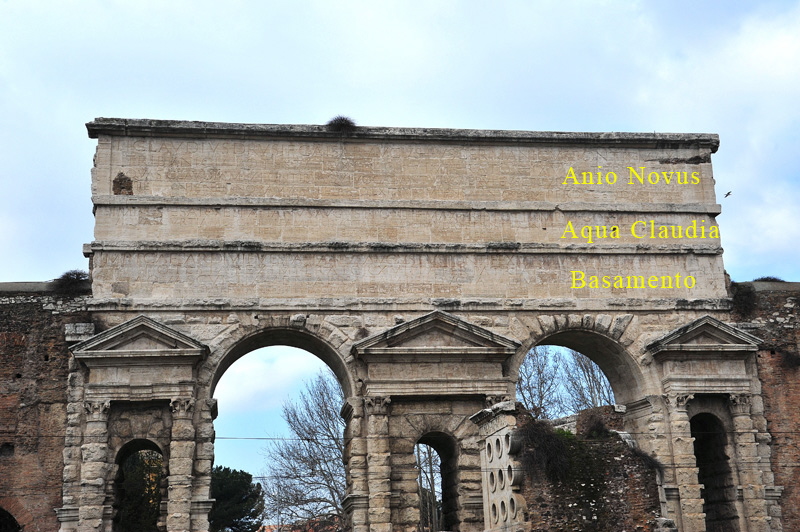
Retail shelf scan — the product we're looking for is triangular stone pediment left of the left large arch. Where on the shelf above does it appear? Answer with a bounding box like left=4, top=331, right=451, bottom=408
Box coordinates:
left=72, top=316, right=205, bottom=356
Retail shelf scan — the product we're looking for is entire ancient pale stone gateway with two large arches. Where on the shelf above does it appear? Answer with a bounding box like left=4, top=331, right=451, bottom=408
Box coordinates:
left=58, top=119, right=780, bottom=532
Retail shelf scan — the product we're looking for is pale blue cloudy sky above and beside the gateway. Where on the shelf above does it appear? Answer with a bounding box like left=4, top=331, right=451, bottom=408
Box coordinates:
left=0, top=0, right=800, bottom=474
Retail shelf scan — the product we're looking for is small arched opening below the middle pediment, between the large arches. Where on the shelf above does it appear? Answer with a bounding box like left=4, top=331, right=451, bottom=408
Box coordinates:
left=414, top=432, right=458, bottom=532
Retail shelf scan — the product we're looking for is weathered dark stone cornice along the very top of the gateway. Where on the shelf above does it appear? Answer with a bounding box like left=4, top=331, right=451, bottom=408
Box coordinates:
left=86, top=118, right=719, bottom=153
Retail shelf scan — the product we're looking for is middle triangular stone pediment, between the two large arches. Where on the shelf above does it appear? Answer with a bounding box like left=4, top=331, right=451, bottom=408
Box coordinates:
left=353, top=310, right=520, bottom=353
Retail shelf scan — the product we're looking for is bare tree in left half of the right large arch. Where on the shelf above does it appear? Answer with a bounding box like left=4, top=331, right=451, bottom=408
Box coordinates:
left=517, top=345, right=564, bottom=419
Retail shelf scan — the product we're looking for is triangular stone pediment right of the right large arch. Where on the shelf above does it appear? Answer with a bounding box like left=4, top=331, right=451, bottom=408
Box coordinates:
left=647, top=316, right=762, bottom=354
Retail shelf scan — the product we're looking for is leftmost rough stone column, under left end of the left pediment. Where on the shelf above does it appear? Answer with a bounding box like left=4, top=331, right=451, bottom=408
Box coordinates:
left=78, top=401, right=111, bottom=532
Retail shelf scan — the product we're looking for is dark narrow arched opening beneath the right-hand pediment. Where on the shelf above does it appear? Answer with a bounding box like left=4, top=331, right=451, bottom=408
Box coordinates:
left=689, top=413, right=739, bottom=532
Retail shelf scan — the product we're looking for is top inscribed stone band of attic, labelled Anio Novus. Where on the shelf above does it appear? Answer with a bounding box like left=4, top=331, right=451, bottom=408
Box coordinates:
left=88, top=119, right=719, bottom=206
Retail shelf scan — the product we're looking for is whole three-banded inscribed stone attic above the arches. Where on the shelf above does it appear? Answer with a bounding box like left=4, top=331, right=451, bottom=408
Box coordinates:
left=86, top=119, right=727, bottom=310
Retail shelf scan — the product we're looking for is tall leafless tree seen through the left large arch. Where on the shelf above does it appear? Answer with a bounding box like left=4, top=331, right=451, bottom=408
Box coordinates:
left=262, top=371, right=346, bottom=524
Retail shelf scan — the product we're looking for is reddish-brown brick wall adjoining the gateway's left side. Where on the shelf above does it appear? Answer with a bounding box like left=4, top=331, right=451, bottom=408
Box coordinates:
left=0, top=283, right=90, bottom=532
